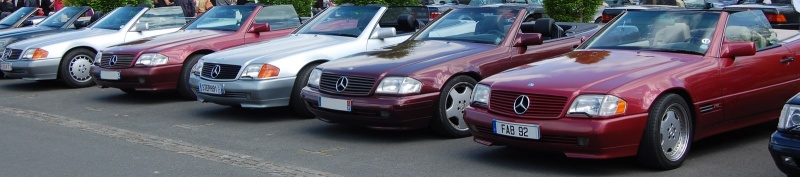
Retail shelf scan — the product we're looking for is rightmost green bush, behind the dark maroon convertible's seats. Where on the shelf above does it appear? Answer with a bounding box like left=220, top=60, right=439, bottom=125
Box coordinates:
left=543, top=0, right=603, bottom=22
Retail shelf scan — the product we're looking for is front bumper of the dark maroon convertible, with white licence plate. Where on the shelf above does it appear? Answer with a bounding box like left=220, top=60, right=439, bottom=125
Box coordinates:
left=302, top=87, right=439, bottom=130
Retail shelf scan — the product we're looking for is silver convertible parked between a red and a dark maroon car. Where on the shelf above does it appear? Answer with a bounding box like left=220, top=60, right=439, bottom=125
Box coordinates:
left=189, top=6, right=427, bottom=117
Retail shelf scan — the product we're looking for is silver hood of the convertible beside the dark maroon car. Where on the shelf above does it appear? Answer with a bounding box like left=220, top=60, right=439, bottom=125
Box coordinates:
left=203, top=34, right=357, bottom=65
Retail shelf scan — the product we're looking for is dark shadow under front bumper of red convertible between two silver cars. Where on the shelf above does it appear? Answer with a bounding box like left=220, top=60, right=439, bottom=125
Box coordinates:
left=94, top=88, right=190, bottom=105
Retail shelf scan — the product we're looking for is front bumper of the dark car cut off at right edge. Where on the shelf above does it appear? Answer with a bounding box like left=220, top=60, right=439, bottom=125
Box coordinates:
left=769, top=131, right=800, bottom=176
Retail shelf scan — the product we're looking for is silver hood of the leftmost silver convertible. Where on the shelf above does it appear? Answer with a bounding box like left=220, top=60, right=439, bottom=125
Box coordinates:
left=9, top=28, right=120, bottom=49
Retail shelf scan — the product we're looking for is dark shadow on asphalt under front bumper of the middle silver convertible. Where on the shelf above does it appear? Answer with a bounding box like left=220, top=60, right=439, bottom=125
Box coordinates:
left=192, top=106, right=304, bottom=123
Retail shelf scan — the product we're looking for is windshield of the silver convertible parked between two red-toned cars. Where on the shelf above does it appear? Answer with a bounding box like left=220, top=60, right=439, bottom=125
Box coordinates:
left=296, top=6, right=380, bottom=37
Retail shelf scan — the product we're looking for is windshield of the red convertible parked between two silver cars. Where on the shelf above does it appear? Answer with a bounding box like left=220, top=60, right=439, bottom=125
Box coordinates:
left=186, top=6, right=255, bottom=31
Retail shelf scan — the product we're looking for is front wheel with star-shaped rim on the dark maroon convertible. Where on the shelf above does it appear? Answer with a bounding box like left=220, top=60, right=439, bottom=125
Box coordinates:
left=431, top=76, right=478, bottom=138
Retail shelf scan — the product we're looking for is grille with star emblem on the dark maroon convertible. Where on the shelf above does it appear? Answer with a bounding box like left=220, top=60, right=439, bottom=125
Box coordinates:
left=319, top=73, right=375, bottom=95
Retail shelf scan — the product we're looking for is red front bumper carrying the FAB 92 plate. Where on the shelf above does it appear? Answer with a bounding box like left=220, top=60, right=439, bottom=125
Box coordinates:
left=464, top=107, right=647, bottom=159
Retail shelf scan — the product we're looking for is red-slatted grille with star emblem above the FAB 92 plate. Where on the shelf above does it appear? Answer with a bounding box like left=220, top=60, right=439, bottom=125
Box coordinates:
left=489, top=90, right=567, bottom=119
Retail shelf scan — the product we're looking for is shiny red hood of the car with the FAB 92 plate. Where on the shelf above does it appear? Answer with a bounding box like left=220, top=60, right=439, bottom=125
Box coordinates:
left=481, top=50, right=702, bottom=97
